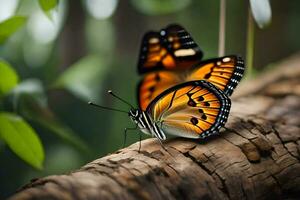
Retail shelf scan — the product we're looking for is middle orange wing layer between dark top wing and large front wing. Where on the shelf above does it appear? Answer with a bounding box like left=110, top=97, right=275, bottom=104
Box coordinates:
left=138, top=56, right=245, bottom=110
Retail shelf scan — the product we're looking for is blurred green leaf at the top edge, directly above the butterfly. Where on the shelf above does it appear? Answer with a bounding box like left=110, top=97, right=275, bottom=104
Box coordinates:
left=131, top=0, right=191, bottom=15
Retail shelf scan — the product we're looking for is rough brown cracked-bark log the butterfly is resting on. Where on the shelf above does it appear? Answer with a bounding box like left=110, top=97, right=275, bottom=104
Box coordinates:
left=11, top=55, right=300, bottom=200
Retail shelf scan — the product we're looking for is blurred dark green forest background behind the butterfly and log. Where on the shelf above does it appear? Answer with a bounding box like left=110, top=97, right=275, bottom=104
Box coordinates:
left=0, top=0, right=300, bottom=199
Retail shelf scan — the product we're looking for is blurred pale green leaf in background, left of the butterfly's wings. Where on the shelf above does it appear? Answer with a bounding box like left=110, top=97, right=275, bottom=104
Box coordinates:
left=52, top=55, right=108, bottom=101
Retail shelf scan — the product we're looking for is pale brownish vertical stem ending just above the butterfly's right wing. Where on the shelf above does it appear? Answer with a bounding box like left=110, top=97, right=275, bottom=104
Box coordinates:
left=218, top=0, right=226, bottom=57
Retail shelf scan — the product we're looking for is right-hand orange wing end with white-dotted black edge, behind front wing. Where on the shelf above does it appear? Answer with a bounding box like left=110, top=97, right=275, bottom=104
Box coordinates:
left=186, top=56, right=245, bottom=96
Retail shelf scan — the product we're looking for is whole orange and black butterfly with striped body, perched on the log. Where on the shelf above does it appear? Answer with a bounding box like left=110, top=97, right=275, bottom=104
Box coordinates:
left=90, top=24, right=245, bottom=148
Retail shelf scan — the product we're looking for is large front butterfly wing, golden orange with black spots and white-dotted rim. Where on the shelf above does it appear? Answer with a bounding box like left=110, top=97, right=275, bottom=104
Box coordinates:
left=146, top=80, right=231, bottom=138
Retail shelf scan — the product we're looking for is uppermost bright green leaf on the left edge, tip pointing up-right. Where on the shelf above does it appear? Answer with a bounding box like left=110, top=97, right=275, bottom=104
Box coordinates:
left=0, top=16, right=27, bottom=44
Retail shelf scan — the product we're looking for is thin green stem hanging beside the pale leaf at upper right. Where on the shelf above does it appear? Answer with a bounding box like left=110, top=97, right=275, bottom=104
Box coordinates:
left=246, top=6, right=254, bottom=76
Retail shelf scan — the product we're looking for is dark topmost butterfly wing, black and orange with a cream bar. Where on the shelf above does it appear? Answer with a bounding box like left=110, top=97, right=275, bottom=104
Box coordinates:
left=138, top=24, right=203, bottom=74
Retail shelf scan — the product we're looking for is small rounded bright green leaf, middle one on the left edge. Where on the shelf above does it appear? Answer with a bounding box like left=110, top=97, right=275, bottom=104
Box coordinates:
left=0, top=60, right=19, bottom=96
